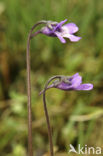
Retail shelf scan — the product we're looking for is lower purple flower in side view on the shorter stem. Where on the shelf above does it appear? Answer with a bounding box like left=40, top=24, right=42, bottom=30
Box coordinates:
left=40, top=73, right=93, bottom=94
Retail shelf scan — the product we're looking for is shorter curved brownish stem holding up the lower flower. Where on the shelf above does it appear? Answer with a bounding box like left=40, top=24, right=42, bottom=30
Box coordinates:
left=43, top=76, right=61, bottom=156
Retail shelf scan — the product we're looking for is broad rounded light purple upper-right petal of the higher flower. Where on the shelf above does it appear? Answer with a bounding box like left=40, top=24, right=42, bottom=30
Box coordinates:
left=63, top=23, right=79, bottom=34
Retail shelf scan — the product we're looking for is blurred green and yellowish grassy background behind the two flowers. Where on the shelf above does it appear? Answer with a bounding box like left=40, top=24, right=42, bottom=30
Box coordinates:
left=0, top=0, right=103, bottom=156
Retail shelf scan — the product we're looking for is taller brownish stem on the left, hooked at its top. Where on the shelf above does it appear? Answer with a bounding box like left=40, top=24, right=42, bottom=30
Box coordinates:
left=26, top=21, right=46, bottom=156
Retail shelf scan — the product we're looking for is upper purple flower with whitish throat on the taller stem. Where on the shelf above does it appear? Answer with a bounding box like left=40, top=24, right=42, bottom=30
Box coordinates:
left=41, top=19, right=81, bottom=43
